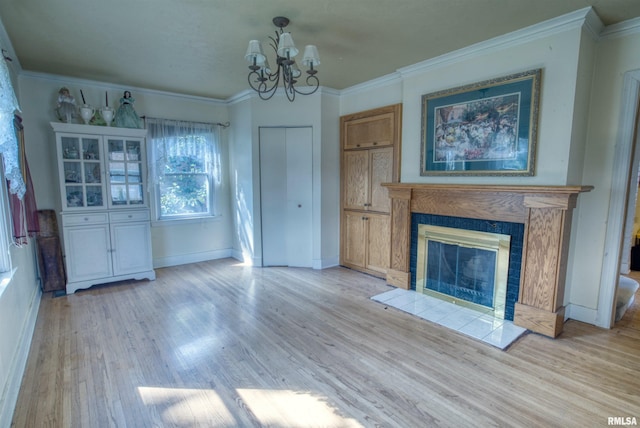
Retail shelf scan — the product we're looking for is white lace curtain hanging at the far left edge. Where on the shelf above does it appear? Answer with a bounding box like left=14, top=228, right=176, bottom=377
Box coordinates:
left=0, top=53, right=26, bottom=199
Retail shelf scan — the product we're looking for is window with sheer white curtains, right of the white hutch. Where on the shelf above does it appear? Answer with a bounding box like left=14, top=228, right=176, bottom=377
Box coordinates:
left=146, top=118, right=220, bottom=220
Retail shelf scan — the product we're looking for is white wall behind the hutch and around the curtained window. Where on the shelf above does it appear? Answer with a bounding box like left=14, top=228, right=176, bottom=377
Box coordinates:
left=20, top=73, right=237, bottom=267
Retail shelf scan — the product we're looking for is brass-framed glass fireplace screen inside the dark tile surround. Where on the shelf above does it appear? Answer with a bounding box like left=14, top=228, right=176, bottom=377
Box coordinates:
left=416, top=225, right=511, bottom=318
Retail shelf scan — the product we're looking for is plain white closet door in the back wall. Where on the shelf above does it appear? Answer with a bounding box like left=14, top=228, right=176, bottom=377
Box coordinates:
left=260, top=127, right=313, bottom=267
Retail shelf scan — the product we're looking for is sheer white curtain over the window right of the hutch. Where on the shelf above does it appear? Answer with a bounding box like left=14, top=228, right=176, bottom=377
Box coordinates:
left=145, top=117, right=221, bottom=186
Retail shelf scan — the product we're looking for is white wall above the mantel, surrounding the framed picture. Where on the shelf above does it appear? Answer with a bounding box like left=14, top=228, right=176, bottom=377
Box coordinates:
left=401, top=27, right=581, bottom=185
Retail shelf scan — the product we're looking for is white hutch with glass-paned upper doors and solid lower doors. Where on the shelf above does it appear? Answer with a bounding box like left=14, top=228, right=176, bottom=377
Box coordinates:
left=51, top=123, right=155, bottom=293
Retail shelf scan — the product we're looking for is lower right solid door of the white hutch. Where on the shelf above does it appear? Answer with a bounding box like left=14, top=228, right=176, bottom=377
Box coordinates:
left=111, top=222, right=153, bottom=275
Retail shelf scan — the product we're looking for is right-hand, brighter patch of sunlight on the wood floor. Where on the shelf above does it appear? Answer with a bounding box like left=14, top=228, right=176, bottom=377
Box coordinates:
left=237, top=389, right=362, bottom=427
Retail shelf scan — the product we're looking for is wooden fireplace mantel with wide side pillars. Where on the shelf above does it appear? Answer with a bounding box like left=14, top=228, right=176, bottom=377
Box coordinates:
left=383, top=183, right=593, bottom=337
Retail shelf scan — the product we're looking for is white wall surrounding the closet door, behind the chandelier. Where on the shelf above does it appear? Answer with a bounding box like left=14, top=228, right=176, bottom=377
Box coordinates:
left=230, top=90, right=340, bottom=268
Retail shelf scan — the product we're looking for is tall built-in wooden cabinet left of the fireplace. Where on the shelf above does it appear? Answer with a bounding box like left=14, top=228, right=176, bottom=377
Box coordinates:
left=340, top=104, right=402, bottom=278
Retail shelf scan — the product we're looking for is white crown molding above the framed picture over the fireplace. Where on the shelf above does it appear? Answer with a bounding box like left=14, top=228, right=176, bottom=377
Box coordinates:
left=398, top=7, right=599, bottom=78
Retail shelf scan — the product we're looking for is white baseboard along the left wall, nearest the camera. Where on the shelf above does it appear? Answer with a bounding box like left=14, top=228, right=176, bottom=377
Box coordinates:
left=0, top=284, right=42, bottom=427
